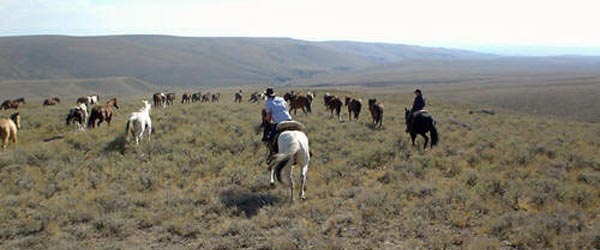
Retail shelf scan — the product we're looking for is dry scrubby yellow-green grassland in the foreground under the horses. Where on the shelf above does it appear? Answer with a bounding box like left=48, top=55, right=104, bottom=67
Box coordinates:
left=0, top=91, right=600, bottom=249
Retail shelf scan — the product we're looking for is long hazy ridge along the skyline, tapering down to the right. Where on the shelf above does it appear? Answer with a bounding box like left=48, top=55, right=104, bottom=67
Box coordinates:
left=0, top=35, right=489, bottom=87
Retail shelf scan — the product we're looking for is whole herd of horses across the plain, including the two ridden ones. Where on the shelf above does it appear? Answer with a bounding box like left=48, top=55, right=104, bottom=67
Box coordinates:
left=0, top=90, right=439, bottom=202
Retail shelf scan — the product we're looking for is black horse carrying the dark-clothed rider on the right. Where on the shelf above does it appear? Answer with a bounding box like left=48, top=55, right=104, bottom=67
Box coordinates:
left=404, top=108, right=439, bottom=149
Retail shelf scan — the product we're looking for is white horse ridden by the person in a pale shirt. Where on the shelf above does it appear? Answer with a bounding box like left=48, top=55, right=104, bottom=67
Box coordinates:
left=269, top=131, right=310, bottom=202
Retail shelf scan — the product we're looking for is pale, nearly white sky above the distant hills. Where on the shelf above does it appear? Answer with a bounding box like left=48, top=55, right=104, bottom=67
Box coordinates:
left=0, top=0, right=600, bottom=55
